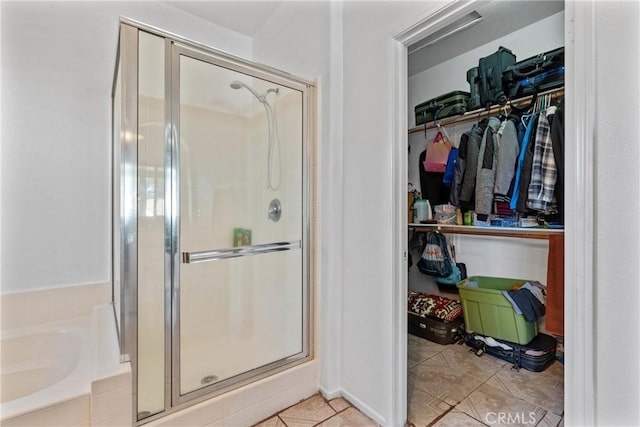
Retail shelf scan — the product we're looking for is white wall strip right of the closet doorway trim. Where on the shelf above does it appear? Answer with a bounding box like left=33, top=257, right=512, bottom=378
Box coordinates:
left=593, top=1, right=640, bottom=425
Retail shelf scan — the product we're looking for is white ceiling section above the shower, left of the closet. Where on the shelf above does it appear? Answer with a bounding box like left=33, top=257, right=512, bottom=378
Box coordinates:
left=164, top=0, right=284, bottom=37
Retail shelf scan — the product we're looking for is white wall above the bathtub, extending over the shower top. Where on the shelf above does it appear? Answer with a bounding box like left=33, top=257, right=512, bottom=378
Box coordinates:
left=1, top=1, right=252, bottom=293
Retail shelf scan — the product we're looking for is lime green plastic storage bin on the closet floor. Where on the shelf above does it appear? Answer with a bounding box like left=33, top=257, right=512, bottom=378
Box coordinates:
left=456, top=276, right=538, bottom=344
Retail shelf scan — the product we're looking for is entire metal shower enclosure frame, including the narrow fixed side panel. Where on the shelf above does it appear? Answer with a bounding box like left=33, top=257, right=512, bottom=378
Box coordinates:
left=113, top=17, right=315, bottom=425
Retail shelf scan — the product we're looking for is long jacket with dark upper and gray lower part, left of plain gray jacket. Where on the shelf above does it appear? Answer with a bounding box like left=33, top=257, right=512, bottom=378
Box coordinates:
left=476, top=117, right=500, bottom=220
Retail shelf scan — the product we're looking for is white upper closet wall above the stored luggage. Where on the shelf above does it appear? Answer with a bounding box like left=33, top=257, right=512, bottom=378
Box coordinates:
left=409, top=12, right=564, bottom=120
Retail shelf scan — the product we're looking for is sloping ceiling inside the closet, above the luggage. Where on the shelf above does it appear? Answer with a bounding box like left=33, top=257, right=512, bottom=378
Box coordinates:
left=408, top=0, right=564, bottom=76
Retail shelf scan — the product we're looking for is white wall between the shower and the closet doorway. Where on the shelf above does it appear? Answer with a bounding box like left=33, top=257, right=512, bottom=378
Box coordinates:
left=342, top=1, right=444, bottom=426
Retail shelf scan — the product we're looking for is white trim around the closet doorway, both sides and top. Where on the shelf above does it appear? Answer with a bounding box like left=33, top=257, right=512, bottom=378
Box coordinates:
left=390, top=0, right=596, bottom=425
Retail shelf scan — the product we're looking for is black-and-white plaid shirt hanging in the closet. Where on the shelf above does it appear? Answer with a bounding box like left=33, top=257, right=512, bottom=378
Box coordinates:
left=527, top=112, right=558, bottom=211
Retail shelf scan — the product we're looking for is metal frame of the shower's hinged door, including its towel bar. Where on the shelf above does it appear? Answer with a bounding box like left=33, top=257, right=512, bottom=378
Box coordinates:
left=165, top=41, right=312, bottom=406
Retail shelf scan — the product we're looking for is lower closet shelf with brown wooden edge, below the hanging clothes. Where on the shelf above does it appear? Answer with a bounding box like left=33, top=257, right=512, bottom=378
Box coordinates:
left=409, top=223, right=564, bottom=240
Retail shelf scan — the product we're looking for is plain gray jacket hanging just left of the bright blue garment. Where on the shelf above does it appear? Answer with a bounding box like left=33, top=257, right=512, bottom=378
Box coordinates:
left=493, top=119, right=520, bottom=202
